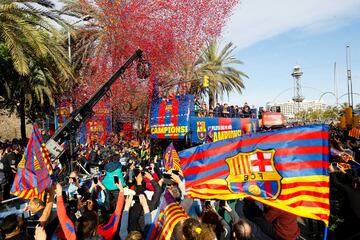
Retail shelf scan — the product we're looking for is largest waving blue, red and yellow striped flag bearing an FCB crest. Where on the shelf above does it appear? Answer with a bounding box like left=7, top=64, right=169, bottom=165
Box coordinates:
left=179, top=125, right=330, bottom=224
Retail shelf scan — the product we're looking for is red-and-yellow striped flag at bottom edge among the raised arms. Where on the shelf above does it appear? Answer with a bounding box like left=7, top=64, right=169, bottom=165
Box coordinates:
left=146, top=190, right=189, bottom=240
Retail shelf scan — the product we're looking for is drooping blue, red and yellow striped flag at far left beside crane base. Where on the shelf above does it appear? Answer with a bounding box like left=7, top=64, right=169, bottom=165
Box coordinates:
left=11, top=124, right=52, bottom=199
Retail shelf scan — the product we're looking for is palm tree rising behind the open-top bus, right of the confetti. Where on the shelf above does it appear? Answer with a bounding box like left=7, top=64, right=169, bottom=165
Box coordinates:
left=184, top=41, right=248, bottom=106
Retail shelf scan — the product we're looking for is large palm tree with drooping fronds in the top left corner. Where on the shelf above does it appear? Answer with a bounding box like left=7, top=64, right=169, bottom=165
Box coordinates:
left=0, top=0, right=72, bottom=141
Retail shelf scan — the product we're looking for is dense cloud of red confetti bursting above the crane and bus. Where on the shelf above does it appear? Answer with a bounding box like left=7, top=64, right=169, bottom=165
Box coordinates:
left=73, top=0, right=239, bottom=119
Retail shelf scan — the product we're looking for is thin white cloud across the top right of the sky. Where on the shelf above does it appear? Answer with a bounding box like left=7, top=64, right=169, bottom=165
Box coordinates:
left=224, top=0, right=360, bottom=49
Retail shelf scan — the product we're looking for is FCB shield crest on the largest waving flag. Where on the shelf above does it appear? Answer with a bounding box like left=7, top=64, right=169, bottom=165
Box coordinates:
left=225, top=149, right=282, bottom=199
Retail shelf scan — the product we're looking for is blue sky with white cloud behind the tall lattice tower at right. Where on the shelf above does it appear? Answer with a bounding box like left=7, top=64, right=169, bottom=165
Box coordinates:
left=220, top=0, right=360, bottom=106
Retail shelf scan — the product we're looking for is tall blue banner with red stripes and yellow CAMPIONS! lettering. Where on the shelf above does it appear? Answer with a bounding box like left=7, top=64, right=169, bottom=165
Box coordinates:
left=150, top=95, right=194, bottom=139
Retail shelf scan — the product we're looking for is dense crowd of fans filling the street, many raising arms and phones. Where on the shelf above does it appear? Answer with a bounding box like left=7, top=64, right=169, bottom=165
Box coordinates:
left=0, top=125, right=360, bottom=240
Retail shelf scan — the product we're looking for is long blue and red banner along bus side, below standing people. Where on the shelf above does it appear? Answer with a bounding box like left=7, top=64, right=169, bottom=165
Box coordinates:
left=191, top=118, right=259, bottom=143
